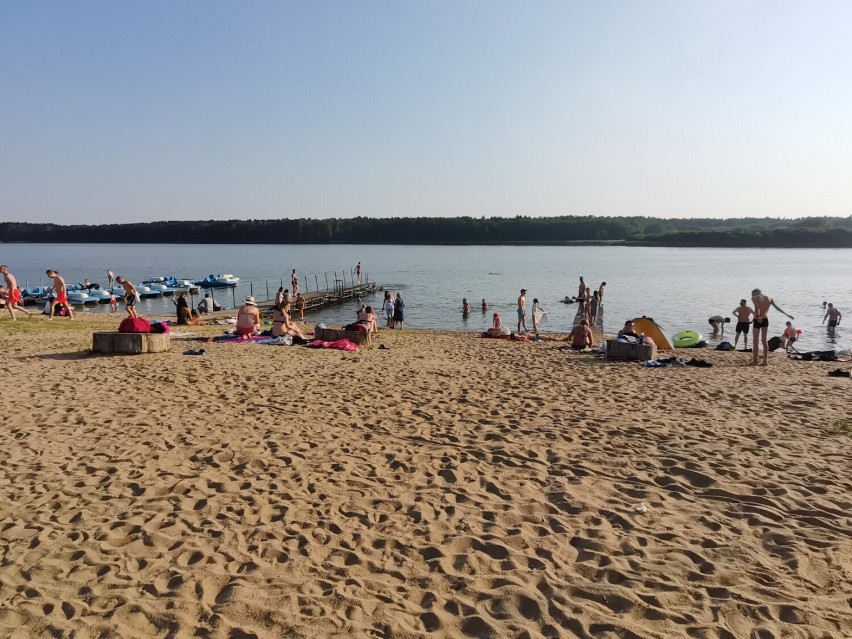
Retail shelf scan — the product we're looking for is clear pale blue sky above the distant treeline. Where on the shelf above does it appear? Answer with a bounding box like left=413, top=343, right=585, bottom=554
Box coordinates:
left=0, top=0, right=852, bottom=223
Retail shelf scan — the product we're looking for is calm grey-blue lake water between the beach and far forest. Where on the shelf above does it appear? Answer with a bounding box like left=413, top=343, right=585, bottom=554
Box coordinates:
left=0, top=244, right=852, bottom=350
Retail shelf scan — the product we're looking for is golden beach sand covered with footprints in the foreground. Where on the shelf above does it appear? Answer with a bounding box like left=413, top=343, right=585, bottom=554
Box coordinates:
left=0, top=317, right=852, bottom=639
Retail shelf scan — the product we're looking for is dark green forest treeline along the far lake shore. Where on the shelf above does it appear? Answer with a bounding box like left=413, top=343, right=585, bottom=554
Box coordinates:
left=0, top=216, right=852, bottom=247
